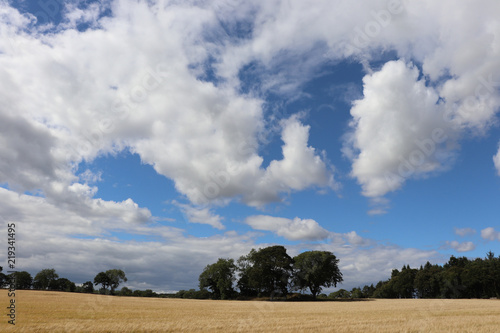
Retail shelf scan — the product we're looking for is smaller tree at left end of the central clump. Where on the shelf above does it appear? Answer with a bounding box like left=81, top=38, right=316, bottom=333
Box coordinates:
left=198, top=258, right=237, bottom=299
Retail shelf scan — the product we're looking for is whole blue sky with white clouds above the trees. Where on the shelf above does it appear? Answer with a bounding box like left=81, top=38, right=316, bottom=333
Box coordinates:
left=0, top=0, right=500, bottom=292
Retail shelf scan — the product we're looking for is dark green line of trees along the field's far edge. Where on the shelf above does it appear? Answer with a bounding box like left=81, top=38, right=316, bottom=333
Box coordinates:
left=0, top=245, right=500, bottom=299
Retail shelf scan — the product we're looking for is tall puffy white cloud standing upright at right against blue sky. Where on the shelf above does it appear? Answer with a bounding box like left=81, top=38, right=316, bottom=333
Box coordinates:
left=344, top=61, right=455, bottom=198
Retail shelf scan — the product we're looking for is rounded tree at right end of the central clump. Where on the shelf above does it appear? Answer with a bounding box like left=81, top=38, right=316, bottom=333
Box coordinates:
left=293, top=251, right=343, bottom=298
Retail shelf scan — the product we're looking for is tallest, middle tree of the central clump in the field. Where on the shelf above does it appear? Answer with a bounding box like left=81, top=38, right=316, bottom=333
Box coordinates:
left=238, top=245, right=293, bottom=298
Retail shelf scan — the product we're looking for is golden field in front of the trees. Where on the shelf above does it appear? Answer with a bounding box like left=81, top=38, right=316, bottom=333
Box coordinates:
left=0, top=290, right=500, bottom=333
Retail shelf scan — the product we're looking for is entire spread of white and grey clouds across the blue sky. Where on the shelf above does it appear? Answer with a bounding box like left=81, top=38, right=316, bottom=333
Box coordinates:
left=0, top=0, right=500, bottom=288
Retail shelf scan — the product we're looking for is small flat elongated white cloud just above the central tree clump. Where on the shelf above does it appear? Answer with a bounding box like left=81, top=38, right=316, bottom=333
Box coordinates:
left=245, top=215, right=329, bottom=241
